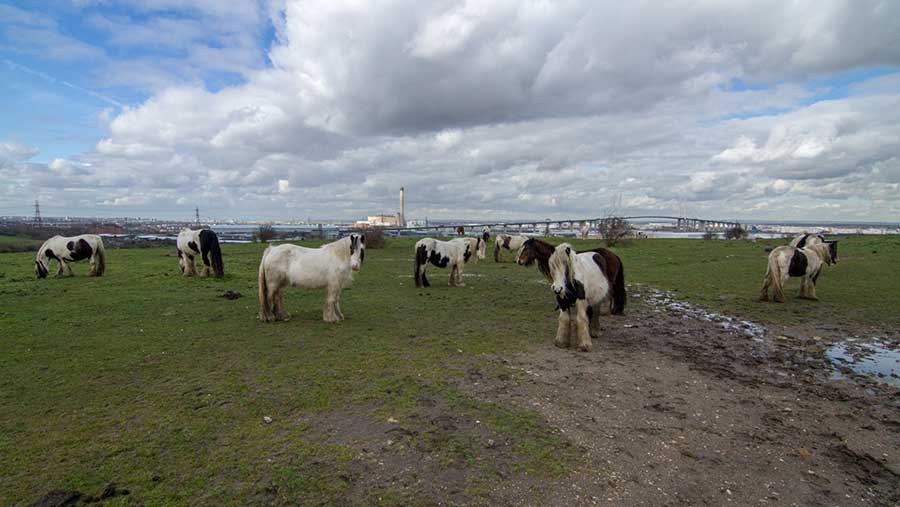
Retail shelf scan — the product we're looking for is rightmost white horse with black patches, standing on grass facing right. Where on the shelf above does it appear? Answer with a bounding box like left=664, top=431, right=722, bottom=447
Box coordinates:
left=759, top=242, right=837, bottom=303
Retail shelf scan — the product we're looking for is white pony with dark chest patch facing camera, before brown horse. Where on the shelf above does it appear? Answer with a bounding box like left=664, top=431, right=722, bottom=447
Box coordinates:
left=549, top=243, right=610, bottom=352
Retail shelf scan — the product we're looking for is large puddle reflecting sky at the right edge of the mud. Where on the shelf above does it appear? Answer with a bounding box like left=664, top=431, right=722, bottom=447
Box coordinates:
left=825, top=338, right=900, bottom=387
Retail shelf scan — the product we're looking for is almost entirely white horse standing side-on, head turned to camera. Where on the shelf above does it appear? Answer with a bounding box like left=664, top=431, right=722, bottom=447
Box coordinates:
left=259, top=234, right=366, bottom=322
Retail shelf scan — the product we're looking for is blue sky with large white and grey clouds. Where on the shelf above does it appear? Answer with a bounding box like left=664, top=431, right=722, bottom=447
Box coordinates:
left=0, top=0, right=900, bottom=221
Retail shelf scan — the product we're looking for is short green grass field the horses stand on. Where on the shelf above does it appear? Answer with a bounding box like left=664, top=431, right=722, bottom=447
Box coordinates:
left=0, top=237, right=900, bottom=505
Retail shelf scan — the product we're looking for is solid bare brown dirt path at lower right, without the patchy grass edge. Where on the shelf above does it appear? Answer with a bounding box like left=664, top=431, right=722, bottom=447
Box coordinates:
left=460, top=292, right=900, bottom=506
